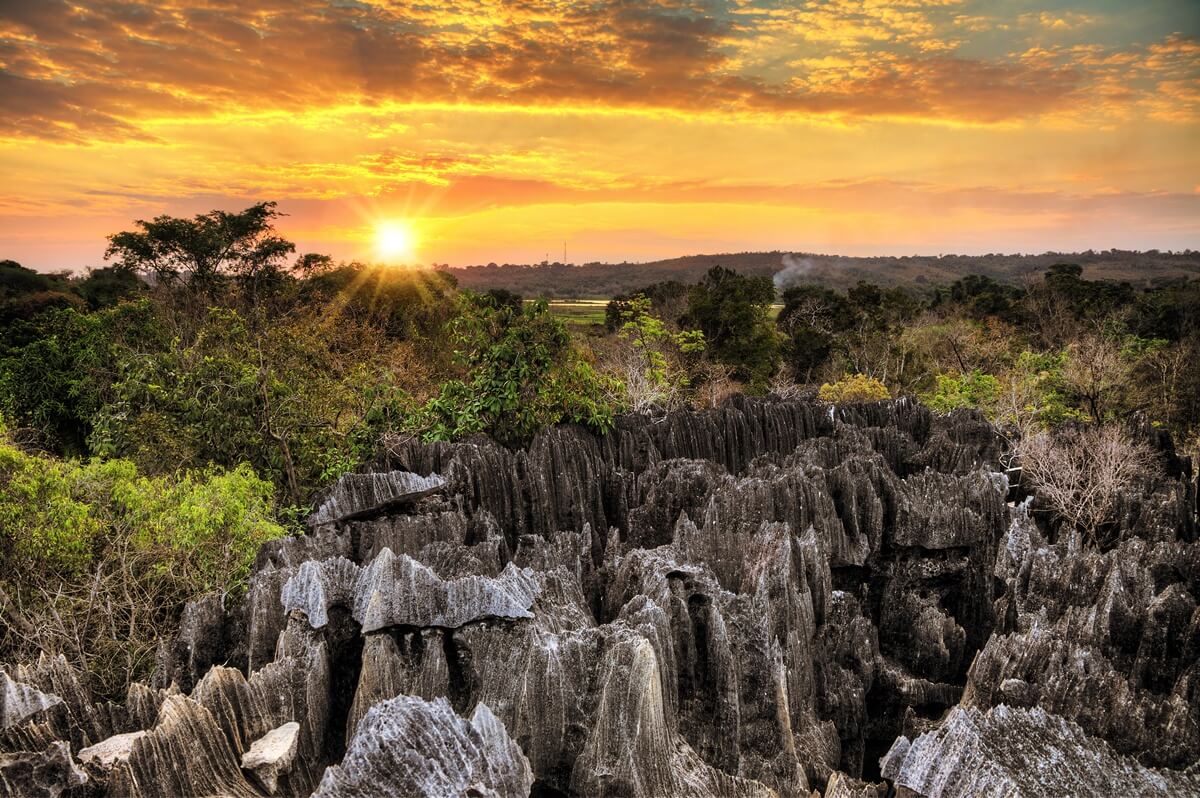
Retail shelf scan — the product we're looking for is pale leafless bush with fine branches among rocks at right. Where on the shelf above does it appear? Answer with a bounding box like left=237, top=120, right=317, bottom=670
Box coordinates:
left=1016, top=425, right=1156, bottom=546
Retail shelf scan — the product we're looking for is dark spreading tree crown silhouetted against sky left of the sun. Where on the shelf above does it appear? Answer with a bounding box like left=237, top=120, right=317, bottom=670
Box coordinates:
left=104, top=202, right=295, bottom=294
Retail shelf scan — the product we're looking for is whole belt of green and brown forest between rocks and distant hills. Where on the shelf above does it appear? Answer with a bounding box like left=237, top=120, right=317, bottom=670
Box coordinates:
left=0, top=203, right=1200, bottom=695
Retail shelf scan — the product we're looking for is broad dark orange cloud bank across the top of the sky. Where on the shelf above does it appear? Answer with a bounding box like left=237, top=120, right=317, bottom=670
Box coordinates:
left=0, top=0, right=1196, bottom=142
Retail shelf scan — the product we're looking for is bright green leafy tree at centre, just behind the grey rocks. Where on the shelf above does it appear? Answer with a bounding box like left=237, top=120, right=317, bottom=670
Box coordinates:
left=410, top=294, right=620, bottom=444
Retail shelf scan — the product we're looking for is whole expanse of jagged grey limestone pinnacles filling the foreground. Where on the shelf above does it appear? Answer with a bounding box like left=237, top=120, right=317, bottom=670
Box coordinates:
left=0, top=398, right=1200, bottom=798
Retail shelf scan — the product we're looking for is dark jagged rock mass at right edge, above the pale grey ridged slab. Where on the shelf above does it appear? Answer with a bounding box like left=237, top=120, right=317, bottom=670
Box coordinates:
left=962, top=509, right=1200, bottom=768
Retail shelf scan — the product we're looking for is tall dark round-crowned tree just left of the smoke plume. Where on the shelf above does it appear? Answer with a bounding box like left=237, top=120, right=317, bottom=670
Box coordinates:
left=683, top=266, right=779, bottom=385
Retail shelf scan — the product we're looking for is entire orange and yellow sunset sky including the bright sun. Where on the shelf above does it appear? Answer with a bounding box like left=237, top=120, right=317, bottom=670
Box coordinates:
left=0, top=0, right=1200, bottom=270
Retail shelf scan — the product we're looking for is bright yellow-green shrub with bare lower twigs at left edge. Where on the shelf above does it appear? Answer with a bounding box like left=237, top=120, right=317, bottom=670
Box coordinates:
left=0, top=422, right=286, bottom=696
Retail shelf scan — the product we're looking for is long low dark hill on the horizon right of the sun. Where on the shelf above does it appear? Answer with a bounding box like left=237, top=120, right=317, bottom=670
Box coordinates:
left=449, top=250, right=1200, bottom=299
